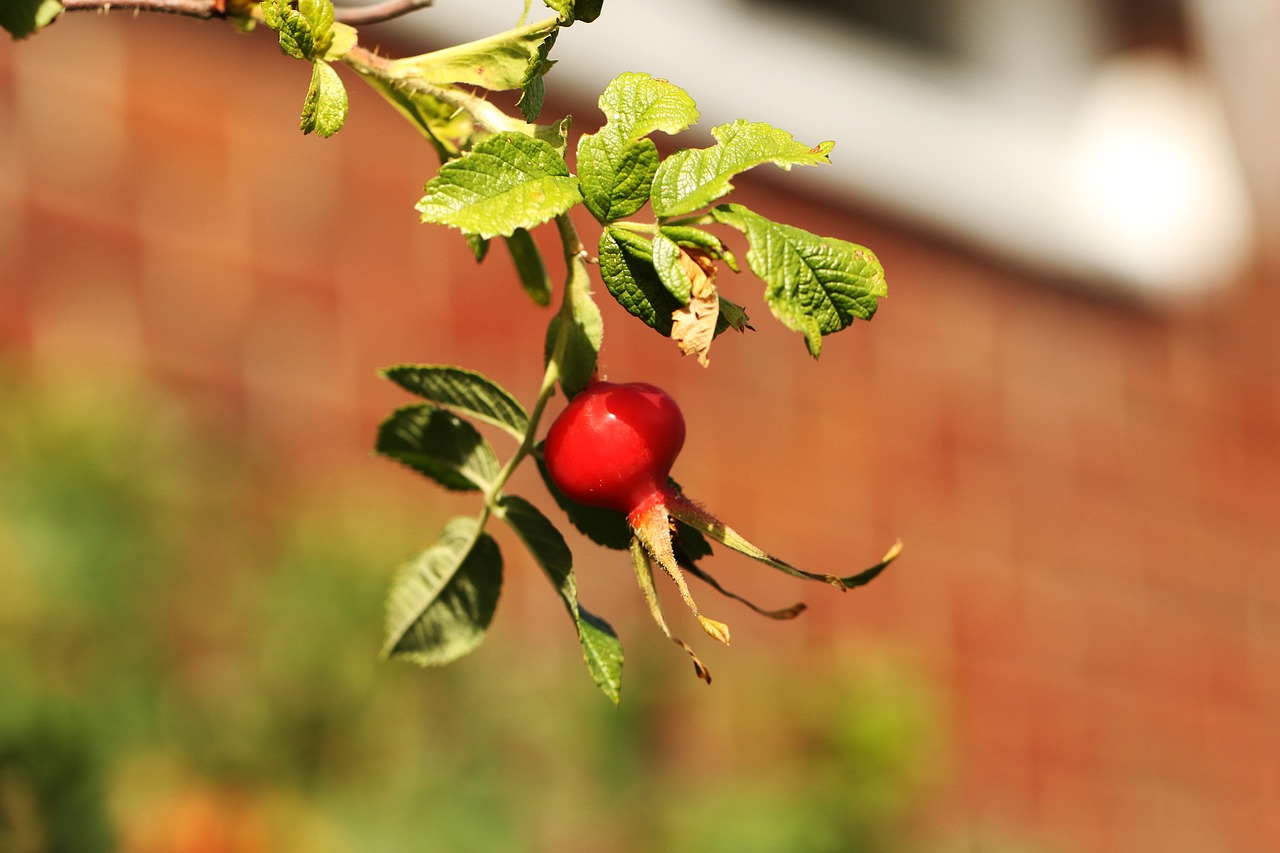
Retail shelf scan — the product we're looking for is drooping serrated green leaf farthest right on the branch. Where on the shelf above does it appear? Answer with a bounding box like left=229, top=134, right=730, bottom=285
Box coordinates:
left=712, top=205, right=887, bottom=357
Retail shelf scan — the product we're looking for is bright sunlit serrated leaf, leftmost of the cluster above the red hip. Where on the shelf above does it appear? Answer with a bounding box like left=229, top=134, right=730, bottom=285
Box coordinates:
left=417, top=133, right=582, bottom=237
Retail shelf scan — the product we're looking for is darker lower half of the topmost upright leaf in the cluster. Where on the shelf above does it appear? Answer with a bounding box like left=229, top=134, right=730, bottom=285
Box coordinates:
left=577, top=128, right=659, bottom=224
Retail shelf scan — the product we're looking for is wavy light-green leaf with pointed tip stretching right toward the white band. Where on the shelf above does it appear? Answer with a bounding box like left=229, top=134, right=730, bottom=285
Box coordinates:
left=652, top=119, right=833, bottom=218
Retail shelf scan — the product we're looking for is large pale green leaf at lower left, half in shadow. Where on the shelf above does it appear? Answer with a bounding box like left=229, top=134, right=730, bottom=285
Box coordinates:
left=383, top=517, right=502, bottom=666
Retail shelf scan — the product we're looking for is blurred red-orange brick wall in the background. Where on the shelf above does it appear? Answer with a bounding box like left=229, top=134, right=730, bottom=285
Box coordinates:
left=0, top=13, right=1280, bottom=853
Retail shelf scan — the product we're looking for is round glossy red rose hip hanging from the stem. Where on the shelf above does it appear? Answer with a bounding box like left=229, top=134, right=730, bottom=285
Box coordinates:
left=544, top=380, right=685, bottom=517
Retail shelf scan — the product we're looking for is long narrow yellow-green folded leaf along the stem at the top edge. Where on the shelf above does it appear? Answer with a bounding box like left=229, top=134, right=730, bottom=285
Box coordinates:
left=388, top=18, right=559, bottom=92
